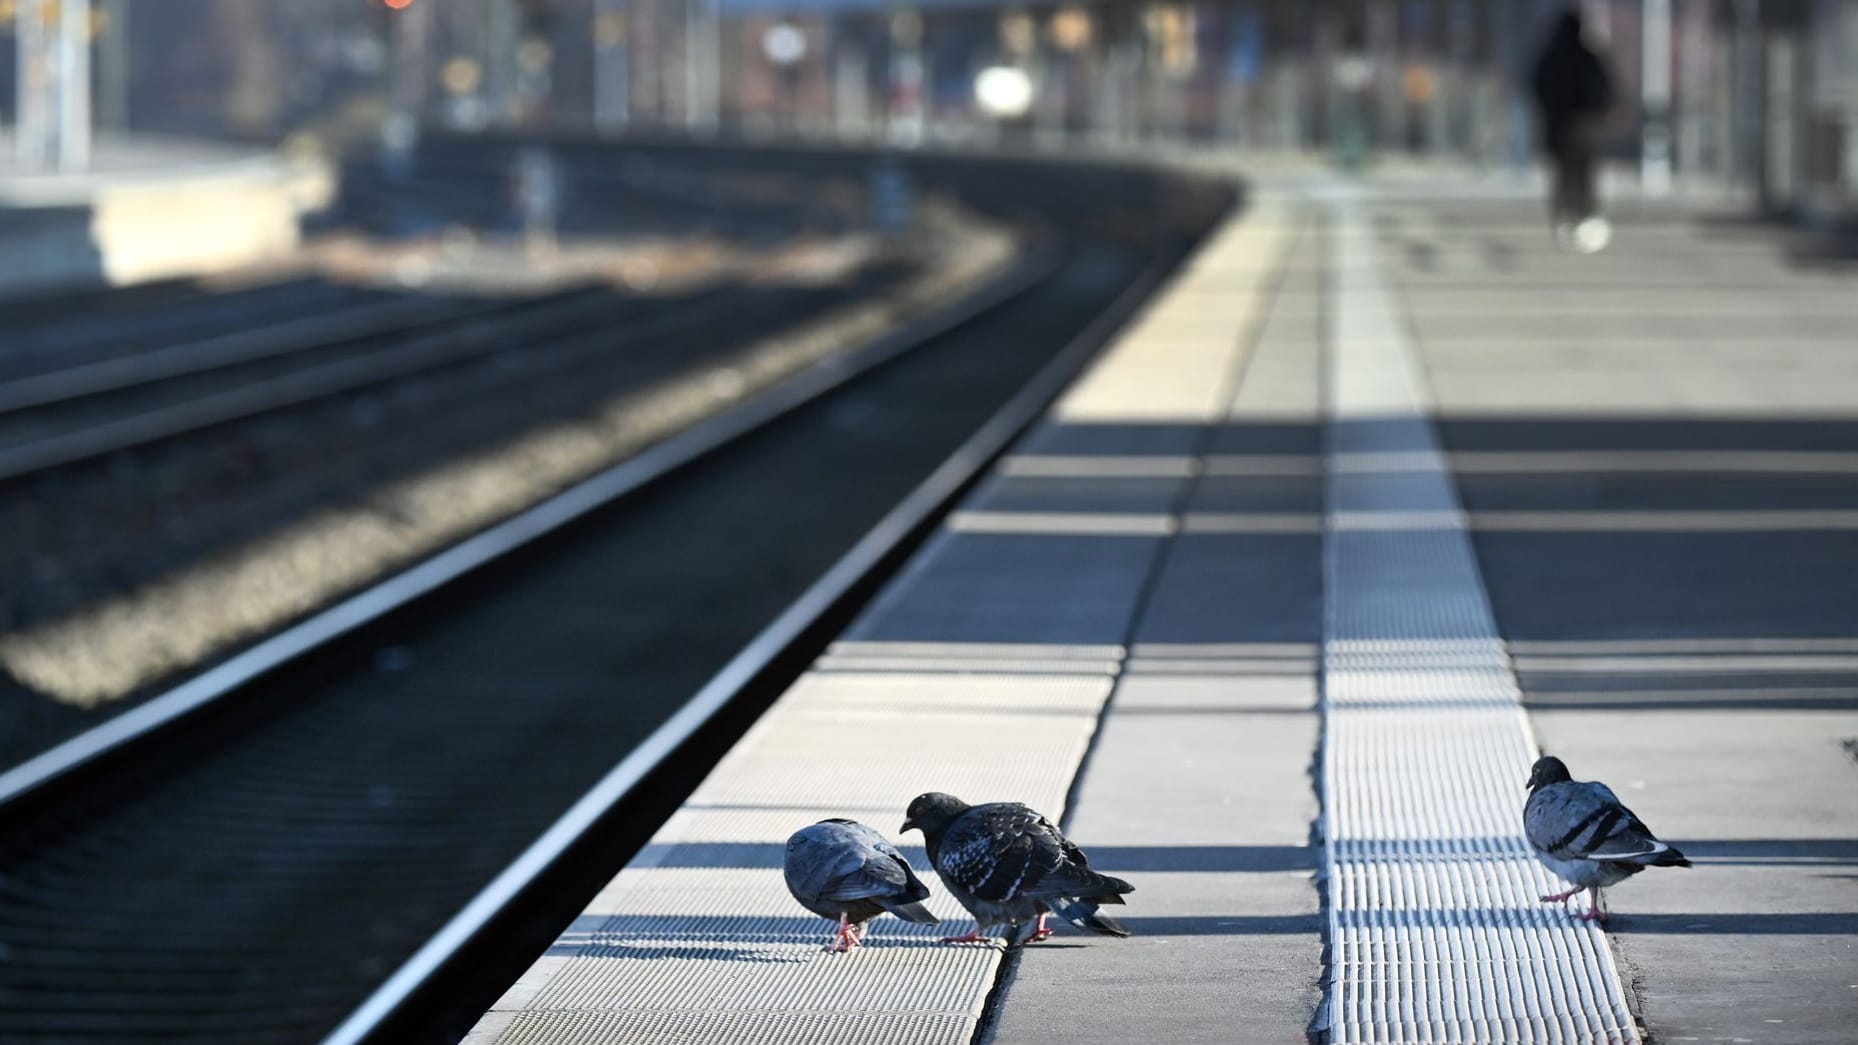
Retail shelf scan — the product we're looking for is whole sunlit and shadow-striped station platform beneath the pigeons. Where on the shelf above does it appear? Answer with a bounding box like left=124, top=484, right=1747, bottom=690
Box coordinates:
left=468, top=171, right=1858, bottom=1045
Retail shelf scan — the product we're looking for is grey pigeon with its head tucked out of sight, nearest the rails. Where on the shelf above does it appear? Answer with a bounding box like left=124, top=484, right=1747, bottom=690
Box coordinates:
left=784, top=818, right=940, bottom=952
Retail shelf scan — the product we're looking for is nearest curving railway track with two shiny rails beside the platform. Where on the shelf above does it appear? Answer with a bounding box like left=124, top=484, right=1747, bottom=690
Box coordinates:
left=0, top=147, right=1221, bottom=1043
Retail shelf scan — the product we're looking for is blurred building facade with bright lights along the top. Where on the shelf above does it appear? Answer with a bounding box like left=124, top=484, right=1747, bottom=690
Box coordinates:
left=0, top=0, right=1858, bottom=214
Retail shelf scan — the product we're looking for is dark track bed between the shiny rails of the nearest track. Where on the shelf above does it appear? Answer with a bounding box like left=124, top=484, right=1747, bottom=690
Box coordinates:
left=0, top=144, right=1219, bottom=1043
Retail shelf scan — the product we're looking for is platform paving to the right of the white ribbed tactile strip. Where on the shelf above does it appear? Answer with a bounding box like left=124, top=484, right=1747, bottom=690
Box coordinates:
left=1377, top=186, right=1858, bottom=1045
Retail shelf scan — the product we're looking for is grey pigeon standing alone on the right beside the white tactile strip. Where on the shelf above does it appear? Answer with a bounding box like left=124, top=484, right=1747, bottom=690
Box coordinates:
left=1522, top=755, right=1691, bottom=922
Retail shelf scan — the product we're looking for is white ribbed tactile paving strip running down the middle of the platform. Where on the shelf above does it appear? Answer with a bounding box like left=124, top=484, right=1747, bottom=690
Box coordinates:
left=1323, top=199, right=1639, bottom=1045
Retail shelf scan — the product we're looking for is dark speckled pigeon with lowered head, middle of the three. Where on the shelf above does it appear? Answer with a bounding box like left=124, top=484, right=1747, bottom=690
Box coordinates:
left=901, top=792, right=1135, bottom=948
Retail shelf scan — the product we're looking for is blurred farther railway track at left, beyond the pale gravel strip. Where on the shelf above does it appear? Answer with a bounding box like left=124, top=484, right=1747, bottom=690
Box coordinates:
left=0, top=162, right=884, bottom=483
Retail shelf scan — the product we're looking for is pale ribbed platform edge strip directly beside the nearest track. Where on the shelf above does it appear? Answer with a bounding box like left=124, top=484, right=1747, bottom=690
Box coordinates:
left=468, top=198, right=1317, bottom=1045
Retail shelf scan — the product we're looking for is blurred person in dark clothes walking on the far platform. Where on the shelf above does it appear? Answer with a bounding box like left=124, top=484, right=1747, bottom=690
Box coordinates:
left=1533, top=9, right=1613, bottom=253
